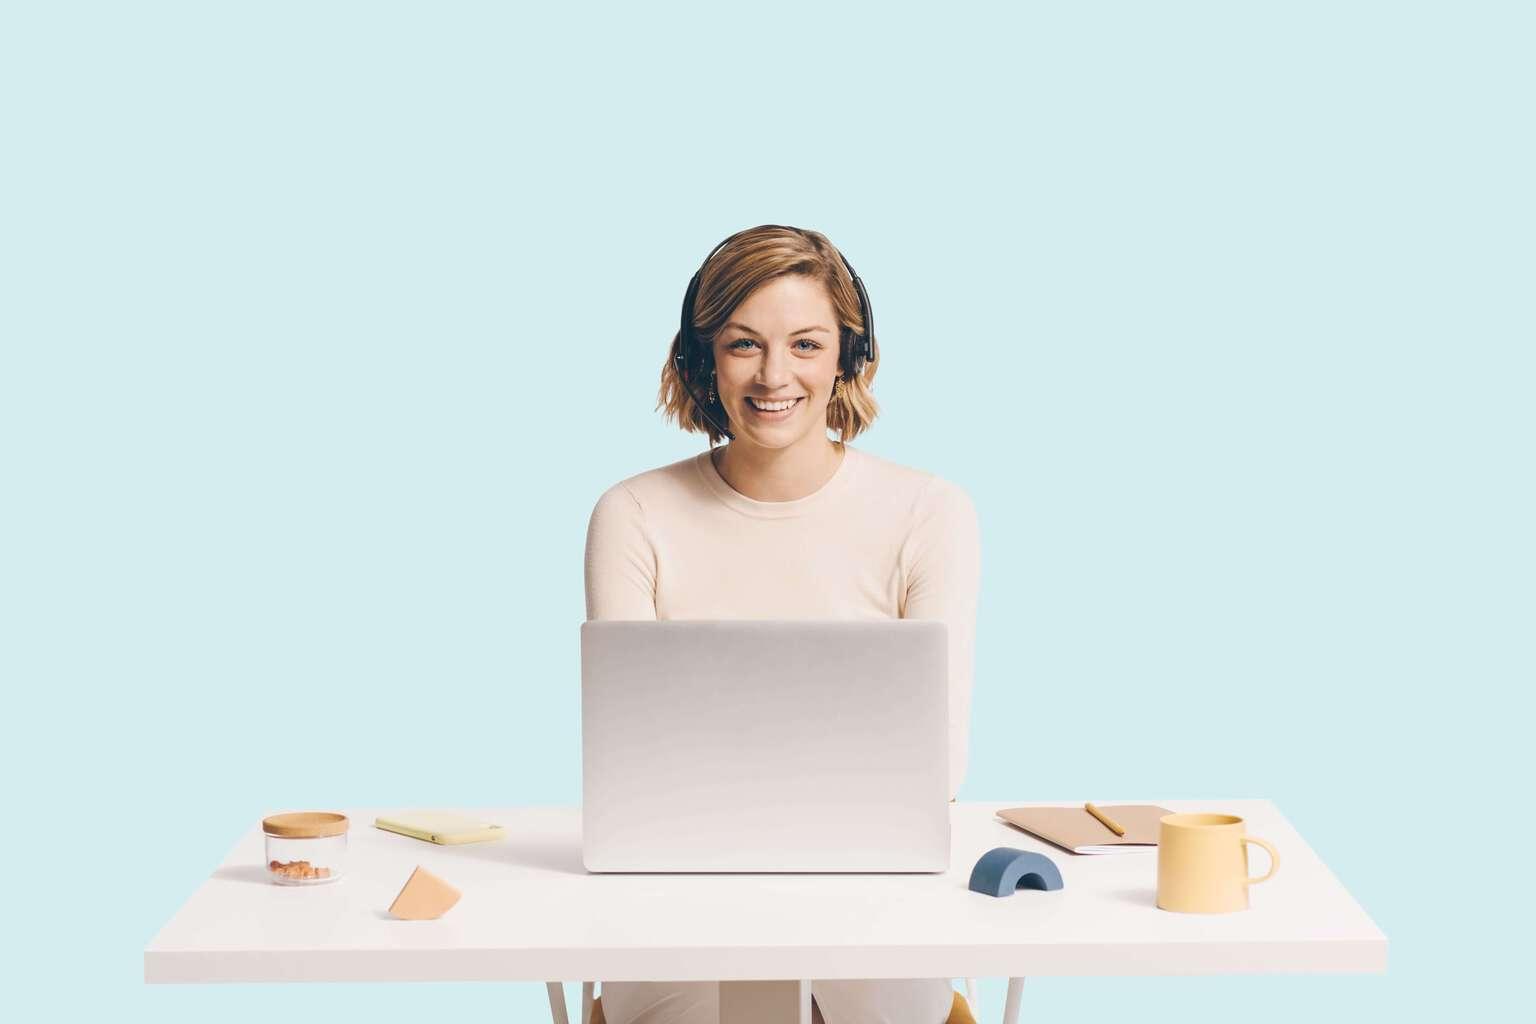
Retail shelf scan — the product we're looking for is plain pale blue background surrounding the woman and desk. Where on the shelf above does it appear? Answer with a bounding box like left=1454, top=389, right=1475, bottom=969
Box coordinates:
left=0, top=3, right=1536, bottom=1022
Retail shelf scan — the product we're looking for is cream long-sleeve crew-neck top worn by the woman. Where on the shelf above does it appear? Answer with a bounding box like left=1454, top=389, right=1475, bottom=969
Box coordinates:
left=585, top=445, right=982, bottom=795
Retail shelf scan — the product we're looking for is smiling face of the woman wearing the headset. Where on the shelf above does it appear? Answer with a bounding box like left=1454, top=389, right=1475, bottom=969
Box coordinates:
left=714, top=275, right=846, bottom=448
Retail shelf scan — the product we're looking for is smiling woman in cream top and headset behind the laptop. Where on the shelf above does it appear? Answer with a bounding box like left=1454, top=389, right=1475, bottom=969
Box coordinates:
left=585, top=224, right=980, bottom=1024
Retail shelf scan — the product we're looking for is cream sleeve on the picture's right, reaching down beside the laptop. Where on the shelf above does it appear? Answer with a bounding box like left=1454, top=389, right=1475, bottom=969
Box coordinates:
left=902, top=477, right=982, bottom=797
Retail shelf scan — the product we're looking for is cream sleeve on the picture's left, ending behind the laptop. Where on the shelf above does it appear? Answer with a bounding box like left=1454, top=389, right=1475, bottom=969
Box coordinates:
left=585, top=484, right=656, bottom=620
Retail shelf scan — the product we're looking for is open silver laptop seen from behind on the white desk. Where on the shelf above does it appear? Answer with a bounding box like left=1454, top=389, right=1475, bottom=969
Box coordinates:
left=581, top=619, right=949, bottom=872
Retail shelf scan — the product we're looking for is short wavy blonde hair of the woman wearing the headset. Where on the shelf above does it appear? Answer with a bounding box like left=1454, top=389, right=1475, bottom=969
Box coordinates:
left=656, top=224, right=880, bottom=447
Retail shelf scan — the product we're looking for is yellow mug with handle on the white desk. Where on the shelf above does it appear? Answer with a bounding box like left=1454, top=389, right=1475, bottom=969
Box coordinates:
left=1157, top=814, right=1279, bottom=913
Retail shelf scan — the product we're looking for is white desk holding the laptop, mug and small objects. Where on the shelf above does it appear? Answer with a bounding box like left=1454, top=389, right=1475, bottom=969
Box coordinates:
left=144, top=798, right=1387, bottom=1015
